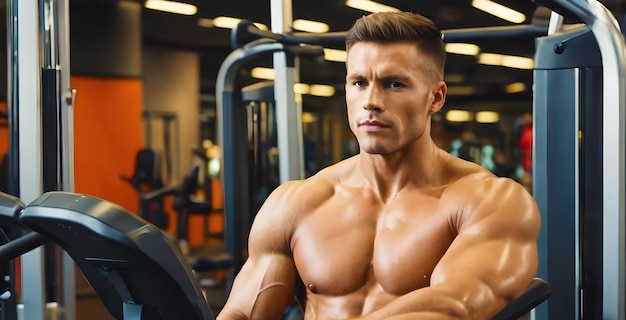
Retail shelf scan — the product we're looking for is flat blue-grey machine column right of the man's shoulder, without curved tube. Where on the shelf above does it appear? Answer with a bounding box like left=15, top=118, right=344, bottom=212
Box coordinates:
left=533, top=25, right=602, bottom=319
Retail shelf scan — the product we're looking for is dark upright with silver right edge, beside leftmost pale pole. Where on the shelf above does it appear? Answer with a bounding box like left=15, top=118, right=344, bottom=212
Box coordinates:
left=39, top=0, right=76, bottom=318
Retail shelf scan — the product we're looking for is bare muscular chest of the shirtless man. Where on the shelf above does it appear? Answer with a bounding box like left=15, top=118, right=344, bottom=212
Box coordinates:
left=292, top=196, right=454, bottom=295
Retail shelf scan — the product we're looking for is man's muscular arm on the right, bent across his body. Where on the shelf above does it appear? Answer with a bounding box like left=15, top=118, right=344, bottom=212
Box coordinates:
left=359, top=178, right=540, bottom=320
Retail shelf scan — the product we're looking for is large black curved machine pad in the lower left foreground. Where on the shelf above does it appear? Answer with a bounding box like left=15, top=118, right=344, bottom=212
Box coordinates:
left=19, top=191, right=214, bottom=320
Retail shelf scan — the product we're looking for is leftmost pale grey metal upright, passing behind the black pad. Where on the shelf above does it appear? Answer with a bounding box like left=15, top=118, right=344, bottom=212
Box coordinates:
left=11, top=0, right=45, bottom=320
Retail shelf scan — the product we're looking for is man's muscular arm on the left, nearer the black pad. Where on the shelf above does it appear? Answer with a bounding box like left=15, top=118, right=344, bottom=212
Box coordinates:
left=217, top=183, right=297, bottom=320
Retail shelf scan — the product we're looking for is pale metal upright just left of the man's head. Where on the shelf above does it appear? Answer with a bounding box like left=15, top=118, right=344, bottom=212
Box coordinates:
left=270, top=0, right=304, bottom=182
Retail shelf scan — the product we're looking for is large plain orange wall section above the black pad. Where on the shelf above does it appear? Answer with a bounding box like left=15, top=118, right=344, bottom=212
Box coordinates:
left=70, top=76, right=143, bottom=212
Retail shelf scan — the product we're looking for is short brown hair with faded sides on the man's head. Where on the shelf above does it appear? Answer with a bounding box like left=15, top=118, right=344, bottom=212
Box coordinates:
left=346, top=12, right=446, bottom=75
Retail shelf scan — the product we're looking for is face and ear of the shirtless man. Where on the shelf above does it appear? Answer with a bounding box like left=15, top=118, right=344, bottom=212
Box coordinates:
left=346, top=42, right=446, bottom=154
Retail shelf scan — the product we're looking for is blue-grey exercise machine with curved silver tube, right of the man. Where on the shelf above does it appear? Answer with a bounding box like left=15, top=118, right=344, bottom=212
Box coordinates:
left=533, top=0, right=626, bottom=319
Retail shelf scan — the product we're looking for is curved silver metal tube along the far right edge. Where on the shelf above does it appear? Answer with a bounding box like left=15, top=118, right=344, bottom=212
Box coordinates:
left=589, top=0, right=626, bottom=319
